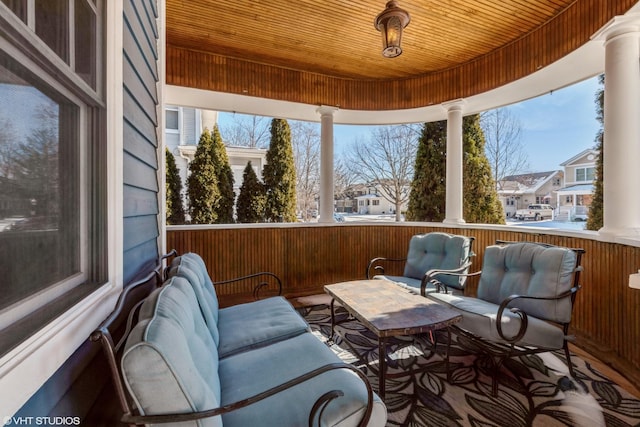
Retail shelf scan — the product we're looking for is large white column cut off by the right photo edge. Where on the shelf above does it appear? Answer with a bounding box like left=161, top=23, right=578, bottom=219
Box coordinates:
left=594, top=15, right=640, bottom=237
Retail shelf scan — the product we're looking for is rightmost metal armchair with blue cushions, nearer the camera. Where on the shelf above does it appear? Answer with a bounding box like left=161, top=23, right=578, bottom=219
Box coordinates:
left=429, top=241, right=584, bottom=395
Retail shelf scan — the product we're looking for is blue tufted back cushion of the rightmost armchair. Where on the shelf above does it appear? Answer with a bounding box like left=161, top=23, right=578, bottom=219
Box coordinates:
left=478, top=243, right=577, bottom=323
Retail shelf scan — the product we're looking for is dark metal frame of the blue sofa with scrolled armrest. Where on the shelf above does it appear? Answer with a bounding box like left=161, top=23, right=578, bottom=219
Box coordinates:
left=89, top=250, right=373, bottom=427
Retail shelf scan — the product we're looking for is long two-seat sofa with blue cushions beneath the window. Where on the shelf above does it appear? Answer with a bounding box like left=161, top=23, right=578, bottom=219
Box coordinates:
left=96, top=254, right=387, bottom=427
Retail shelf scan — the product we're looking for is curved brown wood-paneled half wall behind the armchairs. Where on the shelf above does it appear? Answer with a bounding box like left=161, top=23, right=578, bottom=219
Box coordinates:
left=167, top=224, right=640, bottom=384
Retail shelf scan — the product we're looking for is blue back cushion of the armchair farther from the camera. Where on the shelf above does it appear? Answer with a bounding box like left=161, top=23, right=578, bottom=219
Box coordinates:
left=404, top=232, right=471, bottom=289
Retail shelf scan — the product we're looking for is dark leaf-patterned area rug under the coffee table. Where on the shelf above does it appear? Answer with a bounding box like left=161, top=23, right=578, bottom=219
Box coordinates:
left=301, top=305, right=640, bottom=427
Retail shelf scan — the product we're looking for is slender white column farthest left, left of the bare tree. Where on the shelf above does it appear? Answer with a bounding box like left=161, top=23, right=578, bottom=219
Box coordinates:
left=317, top=106, right=338, bottom=223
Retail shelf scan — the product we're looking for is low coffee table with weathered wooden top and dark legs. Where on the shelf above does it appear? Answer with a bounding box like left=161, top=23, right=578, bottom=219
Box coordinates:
left=324, top=279, right=462, bottom=400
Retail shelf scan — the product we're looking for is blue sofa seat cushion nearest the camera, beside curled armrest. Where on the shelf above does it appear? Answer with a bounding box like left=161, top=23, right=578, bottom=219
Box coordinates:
left=219, top=333, right=387, bottom=427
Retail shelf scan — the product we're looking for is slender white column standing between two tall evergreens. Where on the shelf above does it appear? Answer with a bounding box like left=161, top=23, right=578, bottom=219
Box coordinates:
left=442, top=99, right=465, bottom=224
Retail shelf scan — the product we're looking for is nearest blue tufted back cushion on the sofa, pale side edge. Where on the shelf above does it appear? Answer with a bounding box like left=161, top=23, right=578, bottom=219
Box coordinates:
left=122, top=277, right=222, bottom=427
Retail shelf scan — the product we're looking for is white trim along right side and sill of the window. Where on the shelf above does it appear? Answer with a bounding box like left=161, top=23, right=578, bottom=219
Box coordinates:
left=0, top=1, right=125, bottom=417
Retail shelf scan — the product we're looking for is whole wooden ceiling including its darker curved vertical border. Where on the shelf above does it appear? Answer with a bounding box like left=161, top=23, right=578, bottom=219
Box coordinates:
left=166, top=0, right=635, bottom=109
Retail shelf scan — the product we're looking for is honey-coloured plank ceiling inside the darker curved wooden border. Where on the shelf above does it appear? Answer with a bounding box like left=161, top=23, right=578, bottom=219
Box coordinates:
left=167, top=0, right=574, bottom=79
